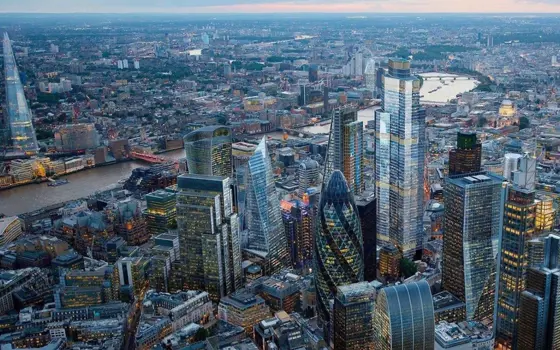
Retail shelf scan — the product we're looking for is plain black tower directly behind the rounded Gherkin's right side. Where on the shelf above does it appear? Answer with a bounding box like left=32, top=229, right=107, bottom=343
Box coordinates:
left=355, top=191, right=377, bottom=282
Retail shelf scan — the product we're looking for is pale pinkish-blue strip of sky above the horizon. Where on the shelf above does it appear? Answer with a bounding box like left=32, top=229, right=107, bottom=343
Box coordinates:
left=0, top=0, right=560, bottom=13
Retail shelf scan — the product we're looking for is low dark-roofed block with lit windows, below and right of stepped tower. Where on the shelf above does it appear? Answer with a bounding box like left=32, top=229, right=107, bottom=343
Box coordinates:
left=218, top=290, right=270, bottom=334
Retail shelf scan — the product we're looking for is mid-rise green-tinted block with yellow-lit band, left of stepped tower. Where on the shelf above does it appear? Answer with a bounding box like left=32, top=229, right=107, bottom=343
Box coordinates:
left=144, top=190, right=177, bottom=235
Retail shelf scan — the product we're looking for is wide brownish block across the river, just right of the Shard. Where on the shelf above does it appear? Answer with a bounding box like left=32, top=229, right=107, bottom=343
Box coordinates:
left=54, top=124, right=99, bottom=152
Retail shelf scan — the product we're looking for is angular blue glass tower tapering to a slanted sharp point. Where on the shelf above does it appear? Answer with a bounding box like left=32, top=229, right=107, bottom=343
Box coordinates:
left=245, top=137, right=291, bottom=274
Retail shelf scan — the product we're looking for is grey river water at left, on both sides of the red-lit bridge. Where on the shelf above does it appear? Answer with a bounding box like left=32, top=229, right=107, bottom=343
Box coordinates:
left=0, top=149, right=185, bottom=215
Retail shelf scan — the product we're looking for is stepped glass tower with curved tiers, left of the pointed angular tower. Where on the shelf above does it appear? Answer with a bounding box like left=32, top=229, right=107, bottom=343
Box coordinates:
left=177, top=174, right=242, bottom=301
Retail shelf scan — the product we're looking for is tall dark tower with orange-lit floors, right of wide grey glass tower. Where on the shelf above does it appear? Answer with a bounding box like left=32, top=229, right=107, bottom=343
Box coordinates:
left=496, top=156, right=537, bottom=349
